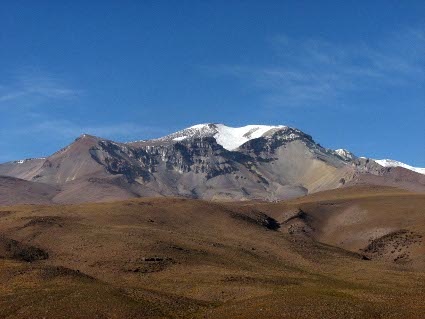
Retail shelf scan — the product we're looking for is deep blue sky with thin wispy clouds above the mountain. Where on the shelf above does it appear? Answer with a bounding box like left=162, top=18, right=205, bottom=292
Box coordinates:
left=0, top=0, right=425, bottom=167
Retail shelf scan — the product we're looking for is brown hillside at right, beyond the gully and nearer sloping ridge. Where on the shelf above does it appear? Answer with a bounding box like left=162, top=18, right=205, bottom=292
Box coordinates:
left=234, top=186, right=425, bottom=270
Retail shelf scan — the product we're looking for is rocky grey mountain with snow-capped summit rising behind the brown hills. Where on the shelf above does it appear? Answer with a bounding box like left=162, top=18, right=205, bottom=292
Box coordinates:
left=0, top=124, right=425, bottom=203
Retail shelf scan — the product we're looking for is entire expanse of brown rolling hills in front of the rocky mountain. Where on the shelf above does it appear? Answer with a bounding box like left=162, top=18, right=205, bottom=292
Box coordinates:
left=0, top=187, right=425, bottom=318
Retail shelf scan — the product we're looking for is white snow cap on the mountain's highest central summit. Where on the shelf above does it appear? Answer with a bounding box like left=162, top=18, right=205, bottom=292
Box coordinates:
left=151, top=123, right=286, bottom=151
